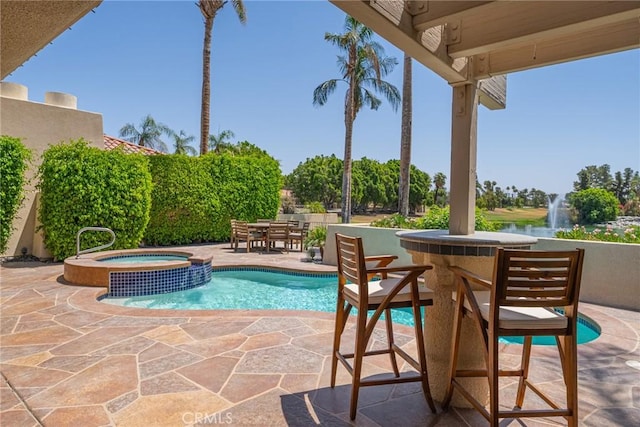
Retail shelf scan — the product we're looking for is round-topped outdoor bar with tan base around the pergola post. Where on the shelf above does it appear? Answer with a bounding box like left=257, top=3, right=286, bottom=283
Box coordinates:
left=396, top=230, right=537, bottom=407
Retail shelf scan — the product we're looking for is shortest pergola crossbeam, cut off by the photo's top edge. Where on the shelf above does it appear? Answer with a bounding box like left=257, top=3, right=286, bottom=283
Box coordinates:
left=412, top=1, right=493, bottom=31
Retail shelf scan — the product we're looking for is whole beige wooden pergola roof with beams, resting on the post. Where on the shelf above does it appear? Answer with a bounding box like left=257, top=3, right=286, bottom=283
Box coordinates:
left=330, top=0, right=640, bottom=85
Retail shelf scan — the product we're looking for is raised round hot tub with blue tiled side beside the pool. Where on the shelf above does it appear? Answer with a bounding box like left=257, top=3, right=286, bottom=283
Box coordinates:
left=64, top=249, right=211, bottom=297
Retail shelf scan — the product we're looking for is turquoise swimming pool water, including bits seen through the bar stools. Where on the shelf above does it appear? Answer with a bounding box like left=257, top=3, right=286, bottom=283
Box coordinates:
left=104, top=269, right=600, bottom=345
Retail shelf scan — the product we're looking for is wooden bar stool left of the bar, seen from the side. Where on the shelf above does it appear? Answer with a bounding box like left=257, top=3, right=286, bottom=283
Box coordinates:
left=331, top=233, right=436, bottom=420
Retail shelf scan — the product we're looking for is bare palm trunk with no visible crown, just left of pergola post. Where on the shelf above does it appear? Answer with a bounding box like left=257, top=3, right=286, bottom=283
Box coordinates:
left=398, top=53, right=413, bottom=216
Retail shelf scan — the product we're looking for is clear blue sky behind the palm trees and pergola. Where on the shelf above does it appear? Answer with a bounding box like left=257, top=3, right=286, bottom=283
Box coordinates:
left=5, top=0, right=640, bottom=193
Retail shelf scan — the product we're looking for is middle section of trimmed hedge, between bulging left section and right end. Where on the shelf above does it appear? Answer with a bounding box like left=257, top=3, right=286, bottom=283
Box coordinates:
left=144, top=155, right=220, bottom=245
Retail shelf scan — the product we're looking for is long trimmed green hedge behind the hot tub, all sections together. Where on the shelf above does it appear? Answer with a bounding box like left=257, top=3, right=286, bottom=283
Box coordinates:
left=35, top=141, right=282, bottom=254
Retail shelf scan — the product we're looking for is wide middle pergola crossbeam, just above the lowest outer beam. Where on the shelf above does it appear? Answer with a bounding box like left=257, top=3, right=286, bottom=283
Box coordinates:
left=448, top=1, right=640, bottom=58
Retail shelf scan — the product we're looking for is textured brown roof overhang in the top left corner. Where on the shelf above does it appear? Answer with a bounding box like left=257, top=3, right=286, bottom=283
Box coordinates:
left=0, top=0, right=102, bottom=79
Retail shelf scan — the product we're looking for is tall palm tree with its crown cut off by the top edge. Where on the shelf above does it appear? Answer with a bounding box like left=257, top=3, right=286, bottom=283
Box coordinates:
left=197, top=0, right=247, bottom=154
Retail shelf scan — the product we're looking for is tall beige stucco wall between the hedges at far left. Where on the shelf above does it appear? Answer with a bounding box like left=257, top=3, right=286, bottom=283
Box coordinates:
left=0, top=88, right=104, bottom=258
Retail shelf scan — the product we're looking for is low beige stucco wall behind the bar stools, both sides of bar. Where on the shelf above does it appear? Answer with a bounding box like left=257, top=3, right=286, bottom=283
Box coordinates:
left=323, top=224, right=640, bottom=311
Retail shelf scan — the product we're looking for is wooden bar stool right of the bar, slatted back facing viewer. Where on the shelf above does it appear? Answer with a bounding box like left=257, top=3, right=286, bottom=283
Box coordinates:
left=443, top=248, right=584, bottom=426
